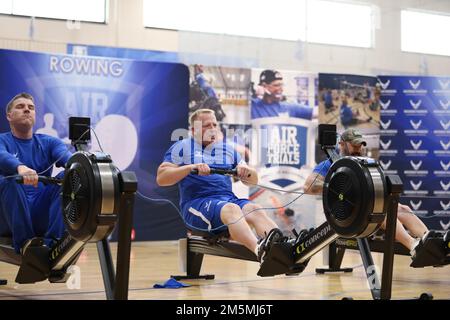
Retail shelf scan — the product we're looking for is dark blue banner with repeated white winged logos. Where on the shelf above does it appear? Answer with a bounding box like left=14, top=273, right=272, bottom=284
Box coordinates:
left=379, top=76, right=450, bottom=230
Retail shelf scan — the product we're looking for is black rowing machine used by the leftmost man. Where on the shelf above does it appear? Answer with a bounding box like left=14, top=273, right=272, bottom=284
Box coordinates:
left=0, top=118, right=137, bottom=299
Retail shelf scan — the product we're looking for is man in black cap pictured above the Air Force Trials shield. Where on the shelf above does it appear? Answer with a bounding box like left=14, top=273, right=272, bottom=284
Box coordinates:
left=251, top=70, right=314, bottom=120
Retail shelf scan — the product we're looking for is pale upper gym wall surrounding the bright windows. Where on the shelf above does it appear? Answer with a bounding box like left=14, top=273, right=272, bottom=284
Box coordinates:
left=0, top=0, right=450, bottom=75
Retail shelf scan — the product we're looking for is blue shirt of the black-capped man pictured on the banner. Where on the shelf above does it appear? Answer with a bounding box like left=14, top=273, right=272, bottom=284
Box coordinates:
left=251, top=98, right=313, bottom=120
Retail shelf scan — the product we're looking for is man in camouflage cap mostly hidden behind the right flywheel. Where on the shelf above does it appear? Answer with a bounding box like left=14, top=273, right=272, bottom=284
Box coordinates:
left=303, top=129, right=428, bottom=256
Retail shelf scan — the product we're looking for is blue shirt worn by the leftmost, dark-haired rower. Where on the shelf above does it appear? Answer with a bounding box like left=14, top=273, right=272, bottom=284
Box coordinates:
left=0, top=132, right=71, bottom=193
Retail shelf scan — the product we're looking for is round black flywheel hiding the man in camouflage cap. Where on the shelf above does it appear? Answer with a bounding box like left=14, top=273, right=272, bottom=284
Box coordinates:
left=323, top=157, right=387, bottom=238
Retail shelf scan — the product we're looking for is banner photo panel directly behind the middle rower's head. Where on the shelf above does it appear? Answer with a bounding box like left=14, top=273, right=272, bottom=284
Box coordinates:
left=189, top=64, right=255, bottom=198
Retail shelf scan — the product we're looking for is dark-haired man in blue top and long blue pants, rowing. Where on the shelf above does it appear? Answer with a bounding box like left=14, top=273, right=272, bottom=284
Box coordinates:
left=0, top=93, right=70, bottom=253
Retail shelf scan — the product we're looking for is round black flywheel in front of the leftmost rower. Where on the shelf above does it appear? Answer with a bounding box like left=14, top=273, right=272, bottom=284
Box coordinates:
left=62, top=151, right=120, bottom=242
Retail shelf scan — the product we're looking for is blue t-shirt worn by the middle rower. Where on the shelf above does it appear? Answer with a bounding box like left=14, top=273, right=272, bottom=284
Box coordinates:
left=163, top=138, right=241, bottom=209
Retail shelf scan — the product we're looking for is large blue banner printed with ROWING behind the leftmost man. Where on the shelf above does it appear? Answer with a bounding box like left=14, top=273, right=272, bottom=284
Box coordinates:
left=0, top=50, right=189, bottom=240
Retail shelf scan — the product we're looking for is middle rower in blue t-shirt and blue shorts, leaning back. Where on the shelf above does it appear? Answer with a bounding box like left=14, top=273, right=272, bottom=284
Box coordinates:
left=156, top=109, right=282, bottom=262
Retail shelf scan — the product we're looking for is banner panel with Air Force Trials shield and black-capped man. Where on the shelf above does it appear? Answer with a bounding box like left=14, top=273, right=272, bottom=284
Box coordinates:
left=249, top=68, right=318, bottom=232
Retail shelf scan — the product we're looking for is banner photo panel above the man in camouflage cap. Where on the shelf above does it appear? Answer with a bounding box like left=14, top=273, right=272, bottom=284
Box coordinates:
left=317, top=73, right=381, bottom=160
